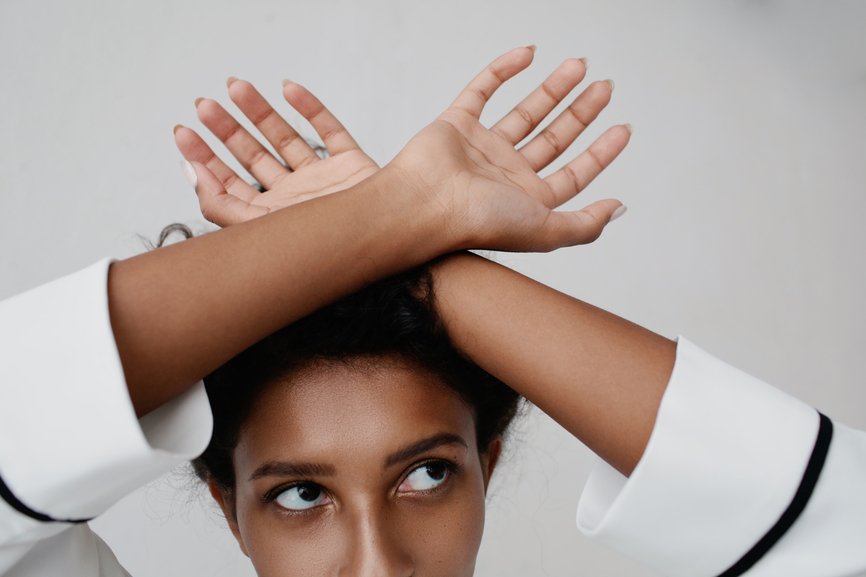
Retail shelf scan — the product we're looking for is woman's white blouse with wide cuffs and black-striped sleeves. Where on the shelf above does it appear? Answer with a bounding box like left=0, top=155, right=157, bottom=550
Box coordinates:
left=0, top=260, right=866, bottom=577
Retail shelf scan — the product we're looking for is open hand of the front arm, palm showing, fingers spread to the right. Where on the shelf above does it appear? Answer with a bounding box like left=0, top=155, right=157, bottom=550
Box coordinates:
left=387, top=47, right=631, bottom=251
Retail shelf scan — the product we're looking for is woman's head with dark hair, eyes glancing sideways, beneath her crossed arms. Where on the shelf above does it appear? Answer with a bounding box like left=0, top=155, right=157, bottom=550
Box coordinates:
left=195, top=269, right=518, bottom=576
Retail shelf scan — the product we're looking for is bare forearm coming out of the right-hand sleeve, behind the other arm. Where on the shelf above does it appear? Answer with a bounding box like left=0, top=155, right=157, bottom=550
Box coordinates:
left=434, top=254, right=676, bottom=475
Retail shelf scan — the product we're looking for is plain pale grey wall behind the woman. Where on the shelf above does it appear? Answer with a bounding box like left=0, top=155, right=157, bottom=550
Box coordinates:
left=0, top=0, right=866, bottom=577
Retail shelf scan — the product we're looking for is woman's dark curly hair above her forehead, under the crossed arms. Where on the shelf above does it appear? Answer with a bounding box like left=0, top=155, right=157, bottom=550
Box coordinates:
left=185, top=258, right=520, bottom=492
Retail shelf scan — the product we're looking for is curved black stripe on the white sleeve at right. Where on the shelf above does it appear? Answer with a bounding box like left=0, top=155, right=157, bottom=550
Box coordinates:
left=719, top=413, right=833, bottom=577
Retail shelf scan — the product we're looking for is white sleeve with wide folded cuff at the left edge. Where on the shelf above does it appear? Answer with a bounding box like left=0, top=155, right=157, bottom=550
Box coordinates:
left=0, top=260, right=212, bottom=576
